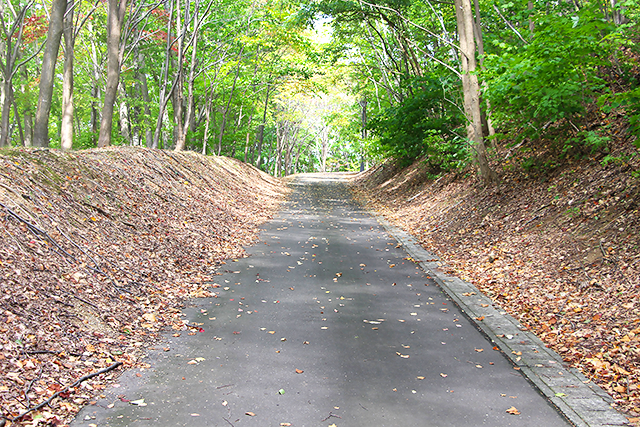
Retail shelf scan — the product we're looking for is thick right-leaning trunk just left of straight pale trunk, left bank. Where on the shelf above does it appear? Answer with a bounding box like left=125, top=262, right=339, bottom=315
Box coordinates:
left=33, top=0, right=67, bottom=147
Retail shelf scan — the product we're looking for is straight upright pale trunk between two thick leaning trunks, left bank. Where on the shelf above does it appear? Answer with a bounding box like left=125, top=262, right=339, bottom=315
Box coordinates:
left=60, top=4, right=75, bottom=150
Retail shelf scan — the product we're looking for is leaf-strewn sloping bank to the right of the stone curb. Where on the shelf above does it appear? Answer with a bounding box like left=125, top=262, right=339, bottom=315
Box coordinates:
left=354, top=143, right=640, bottom=421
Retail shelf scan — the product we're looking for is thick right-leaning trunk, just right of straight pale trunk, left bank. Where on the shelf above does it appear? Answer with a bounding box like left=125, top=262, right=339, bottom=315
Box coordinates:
left=98, top=0, right=127, bottom=147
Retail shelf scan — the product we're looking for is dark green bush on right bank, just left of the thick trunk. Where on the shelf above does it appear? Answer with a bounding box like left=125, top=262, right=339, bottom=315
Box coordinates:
left=369, top=75, right=468, bottom=173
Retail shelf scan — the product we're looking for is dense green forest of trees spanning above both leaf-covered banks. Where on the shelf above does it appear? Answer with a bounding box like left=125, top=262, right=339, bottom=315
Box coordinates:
left=0, top=0, right=640, bottom=178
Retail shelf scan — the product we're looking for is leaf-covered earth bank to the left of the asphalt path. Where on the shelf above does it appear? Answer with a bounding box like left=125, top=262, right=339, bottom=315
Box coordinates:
left=0, top=148, right=288, bottom=425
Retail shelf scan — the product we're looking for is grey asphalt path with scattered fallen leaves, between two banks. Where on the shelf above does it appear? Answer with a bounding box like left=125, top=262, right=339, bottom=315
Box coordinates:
left=72, top=175, right=568, bottom=427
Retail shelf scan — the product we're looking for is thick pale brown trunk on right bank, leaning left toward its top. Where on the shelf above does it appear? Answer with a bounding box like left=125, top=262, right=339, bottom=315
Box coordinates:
left=455, top=0, right=497, bottom=184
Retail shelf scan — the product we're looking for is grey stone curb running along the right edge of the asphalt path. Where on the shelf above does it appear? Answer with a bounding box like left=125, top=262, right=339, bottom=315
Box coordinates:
left=371, top=217, right=630, bottom=427
